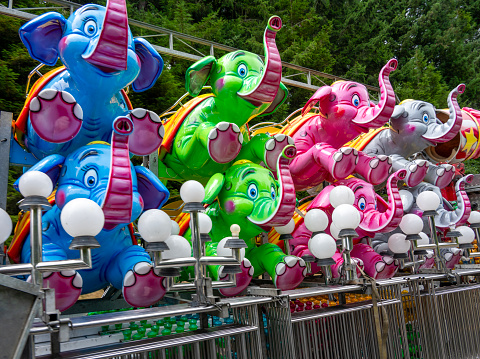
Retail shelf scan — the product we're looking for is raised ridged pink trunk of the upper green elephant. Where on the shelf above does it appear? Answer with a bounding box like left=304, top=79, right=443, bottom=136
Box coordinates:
left=238, top=16, right=282, bottom=105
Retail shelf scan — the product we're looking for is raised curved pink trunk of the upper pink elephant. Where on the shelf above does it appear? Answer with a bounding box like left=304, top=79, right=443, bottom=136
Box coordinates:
left=353, top=59, right=398, bottom=131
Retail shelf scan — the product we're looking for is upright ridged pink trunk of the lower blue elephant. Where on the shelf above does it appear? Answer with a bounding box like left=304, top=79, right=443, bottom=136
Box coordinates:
left=102, top=117, right=133, bottom=230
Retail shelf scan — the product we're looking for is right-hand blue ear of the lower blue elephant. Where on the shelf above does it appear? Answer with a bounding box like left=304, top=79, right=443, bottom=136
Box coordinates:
left=135, top=166, right=170, bottom=211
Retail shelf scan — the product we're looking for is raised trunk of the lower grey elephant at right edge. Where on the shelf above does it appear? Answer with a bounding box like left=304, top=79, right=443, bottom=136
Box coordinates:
left=435, top=175, right=473, bottom=228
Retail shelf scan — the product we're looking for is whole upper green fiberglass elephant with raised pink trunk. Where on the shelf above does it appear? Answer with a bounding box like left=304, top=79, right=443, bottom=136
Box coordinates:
left=159, top=16, right=293, bottom=184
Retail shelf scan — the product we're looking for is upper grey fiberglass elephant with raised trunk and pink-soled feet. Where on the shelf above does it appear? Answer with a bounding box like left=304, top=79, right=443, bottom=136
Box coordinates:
left=352, top=84, right=465, bottom=188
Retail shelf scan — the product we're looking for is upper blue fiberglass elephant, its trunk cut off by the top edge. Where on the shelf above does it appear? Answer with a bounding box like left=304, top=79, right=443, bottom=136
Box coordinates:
left=15, top=0, right=163, bottom=159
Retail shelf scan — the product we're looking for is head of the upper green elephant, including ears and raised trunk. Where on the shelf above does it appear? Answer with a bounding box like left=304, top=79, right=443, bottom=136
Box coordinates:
left=185, top=16, right=288, bottom=125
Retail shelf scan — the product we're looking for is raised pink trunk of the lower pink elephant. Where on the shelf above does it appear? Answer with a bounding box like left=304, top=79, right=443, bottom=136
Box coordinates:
left=359, top=170, right=407, bottom=233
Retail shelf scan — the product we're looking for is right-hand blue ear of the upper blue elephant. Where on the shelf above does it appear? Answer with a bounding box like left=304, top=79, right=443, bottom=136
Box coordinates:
left=132, top=38, right=163, bottom=92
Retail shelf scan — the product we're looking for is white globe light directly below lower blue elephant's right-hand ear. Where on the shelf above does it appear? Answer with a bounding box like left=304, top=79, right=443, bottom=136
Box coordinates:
left=138, top=209, right=172, bottom=243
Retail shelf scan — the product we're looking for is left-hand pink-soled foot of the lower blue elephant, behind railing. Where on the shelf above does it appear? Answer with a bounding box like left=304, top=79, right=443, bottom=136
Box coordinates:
left=27, top=270, right=83, bottom=312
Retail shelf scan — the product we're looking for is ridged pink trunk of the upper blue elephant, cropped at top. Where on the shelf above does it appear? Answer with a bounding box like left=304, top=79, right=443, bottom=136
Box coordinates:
left=85, top=0, right=128, bottom=73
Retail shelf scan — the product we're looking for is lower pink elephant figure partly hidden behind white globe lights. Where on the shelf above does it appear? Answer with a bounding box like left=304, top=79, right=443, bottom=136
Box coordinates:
left=290, top=170, right=407, bottom=279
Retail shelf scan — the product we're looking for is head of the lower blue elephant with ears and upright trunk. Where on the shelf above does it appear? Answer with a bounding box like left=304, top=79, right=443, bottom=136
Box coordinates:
left=15, top=117, right=169, bottom=230
